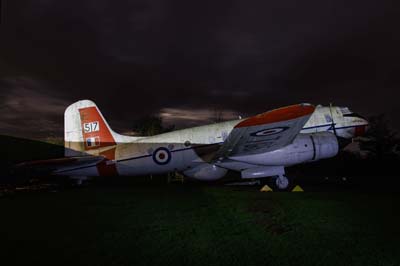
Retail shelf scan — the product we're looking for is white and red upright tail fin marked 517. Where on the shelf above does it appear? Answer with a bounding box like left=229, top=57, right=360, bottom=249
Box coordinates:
left=64, top=100, right=120, bottom=156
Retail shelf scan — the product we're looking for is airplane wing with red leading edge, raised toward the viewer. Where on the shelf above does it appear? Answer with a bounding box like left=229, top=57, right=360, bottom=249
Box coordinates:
left=214, top=104, right=315, bottom=162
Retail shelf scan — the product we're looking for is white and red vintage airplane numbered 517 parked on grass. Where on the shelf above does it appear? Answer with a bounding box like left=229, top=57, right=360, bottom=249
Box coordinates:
left=18, top=100, right=368, bottom=190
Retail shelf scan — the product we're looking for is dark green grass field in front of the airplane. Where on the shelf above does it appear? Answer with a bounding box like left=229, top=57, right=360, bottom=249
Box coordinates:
left=0, top=184, right=400, bottom=265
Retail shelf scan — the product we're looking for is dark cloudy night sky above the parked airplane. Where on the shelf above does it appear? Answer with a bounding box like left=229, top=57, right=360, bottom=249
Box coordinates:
left=0, top=0, right=400, bottom=138
